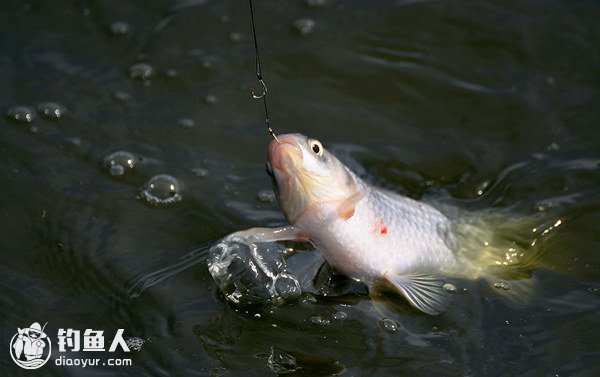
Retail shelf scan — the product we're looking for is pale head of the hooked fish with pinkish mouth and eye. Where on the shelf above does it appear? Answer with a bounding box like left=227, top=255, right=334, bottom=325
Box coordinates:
left=267, top=134, right=357, bottom=225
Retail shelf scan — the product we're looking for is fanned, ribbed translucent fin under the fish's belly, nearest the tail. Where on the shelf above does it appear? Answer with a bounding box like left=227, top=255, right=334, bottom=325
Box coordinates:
left=384, top=273, right=451, bottom=315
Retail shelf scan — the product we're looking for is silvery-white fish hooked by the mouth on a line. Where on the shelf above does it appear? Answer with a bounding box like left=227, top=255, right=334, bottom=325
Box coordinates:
left=231, top=134, right=540, bottom=315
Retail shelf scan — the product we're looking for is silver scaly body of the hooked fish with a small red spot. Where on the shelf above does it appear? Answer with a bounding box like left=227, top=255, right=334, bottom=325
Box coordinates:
left=293, top=178, right=458, bottom=282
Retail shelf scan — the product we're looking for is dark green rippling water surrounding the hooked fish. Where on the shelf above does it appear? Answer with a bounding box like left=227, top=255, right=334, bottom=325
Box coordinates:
left=0, top=0, right=600, bottom=376
